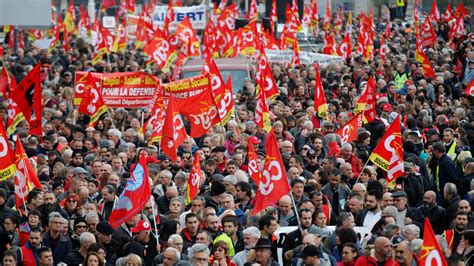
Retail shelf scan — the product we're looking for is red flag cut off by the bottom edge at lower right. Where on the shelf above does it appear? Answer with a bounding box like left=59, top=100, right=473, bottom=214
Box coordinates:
left=420, top=218, right=448, bottom=266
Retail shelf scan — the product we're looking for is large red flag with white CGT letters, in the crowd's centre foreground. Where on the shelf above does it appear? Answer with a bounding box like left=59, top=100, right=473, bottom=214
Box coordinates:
left=252, top=130, right=291, bottom=214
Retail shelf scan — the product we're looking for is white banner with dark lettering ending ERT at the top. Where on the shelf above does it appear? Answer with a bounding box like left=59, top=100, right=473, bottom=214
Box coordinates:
left=153, top=4, right=206, bottom=30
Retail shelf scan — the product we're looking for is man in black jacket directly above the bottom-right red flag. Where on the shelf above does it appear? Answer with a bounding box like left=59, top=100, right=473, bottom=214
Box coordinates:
left=420, top=190, right=446, bottom=235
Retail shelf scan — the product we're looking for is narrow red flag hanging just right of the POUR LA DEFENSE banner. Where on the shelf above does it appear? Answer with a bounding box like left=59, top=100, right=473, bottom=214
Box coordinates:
left=160, top=94, right=188, bottom=162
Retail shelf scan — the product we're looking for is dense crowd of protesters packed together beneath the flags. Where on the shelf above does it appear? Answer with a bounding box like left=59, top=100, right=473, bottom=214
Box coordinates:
left=0, top=1, right=474, bottom=266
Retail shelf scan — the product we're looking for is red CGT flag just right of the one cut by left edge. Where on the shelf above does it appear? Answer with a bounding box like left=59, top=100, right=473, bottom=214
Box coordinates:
left=14, top=140, right=41, bottom=215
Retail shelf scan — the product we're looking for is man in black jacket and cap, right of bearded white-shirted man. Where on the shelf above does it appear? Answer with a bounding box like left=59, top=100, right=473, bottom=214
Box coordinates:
left=392, top=191, right=425, bottom=230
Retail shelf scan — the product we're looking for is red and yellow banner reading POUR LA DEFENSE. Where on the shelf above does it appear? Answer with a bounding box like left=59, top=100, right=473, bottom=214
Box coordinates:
left=74, top=71, right=159, bottom=108
